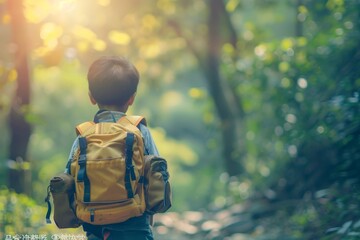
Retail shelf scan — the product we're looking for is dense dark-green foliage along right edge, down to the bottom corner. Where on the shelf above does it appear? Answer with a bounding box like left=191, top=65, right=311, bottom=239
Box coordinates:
left=219, top=1, right=360, bottom=239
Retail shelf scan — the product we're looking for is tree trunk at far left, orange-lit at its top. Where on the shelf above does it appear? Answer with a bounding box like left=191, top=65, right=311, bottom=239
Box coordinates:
left=8, top=0, right=31, bottom=194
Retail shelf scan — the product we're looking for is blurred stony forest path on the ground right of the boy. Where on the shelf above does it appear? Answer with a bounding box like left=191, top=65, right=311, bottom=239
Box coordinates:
left=150, top=203, right=302, bottom=240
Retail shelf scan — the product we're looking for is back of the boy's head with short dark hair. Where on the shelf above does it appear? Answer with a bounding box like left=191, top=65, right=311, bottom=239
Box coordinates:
left=87, top=57, right=139, bottom=107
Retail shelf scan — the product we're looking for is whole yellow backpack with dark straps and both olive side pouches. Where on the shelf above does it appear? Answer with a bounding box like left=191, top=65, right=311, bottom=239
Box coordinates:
left=46, top=116, right=171, bottom=228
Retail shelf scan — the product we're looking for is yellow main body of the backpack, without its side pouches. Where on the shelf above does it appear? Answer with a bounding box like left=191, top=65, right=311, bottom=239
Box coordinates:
left=71, top=116, right=146, bottom=225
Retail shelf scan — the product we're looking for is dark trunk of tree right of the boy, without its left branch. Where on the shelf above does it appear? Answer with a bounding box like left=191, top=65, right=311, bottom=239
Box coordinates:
left=204, top=0, right=245, bottom=176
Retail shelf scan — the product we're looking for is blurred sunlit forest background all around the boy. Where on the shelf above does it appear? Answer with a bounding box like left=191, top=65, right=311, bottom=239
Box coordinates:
left=0, top=0, right=360, bottom=240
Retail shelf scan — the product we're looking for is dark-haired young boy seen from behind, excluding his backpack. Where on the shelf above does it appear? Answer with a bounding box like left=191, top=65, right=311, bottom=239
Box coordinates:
left=67, top=57, right=159, bottom=240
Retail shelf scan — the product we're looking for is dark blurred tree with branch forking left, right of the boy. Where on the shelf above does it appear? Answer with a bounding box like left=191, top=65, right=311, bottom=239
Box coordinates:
left=168, top=0, right=246, bottom=176
